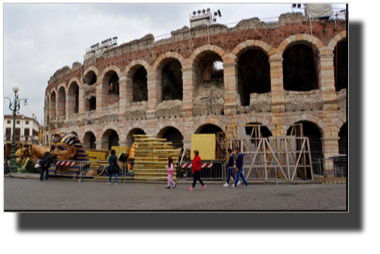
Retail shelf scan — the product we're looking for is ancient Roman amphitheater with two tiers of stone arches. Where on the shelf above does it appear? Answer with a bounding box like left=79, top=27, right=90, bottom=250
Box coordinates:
left=44, top=13, right=348, bottom=167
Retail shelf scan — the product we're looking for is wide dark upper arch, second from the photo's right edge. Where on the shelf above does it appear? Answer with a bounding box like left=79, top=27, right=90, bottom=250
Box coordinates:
left=283, top=44, right=318, bottom=92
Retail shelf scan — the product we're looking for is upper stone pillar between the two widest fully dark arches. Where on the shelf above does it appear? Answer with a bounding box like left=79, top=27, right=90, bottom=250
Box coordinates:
left=269, top=58, right=286, bottom=128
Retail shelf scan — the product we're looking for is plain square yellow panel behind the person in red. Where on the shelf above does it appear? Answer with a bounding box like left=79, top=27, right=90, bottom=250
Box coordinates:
left=190, top=134, right=216, bottom=160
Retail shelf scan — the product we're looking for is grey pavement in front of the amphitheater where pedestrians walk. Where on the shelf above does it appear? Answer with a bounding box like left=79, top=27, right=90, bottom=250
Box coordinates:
left=4, top=177, right=346, bottom=212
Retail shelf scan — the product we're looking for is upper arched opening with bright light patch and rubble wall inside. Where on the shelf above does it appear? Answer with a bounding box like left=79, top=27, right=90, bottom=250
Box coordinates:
left=193, top=51, right=224, bottom=116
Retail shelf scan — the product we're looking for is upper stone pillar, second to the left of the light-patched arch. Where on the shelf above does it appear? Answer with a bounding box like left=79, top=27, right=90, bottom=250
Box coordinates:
left=146, top=72, right=162, bottom=120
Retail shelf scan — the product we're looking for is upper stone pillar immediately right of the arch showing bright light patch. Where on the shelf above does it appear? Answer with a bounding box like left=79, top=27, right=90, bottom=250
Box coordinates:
left=223, top=62, right=239, bottom=116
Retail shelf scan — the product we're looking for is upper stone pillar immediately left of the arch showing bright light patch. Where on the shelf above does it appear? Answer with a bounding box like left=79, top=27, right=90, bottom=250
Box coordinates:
left=182, top=66, right=196, bottom=117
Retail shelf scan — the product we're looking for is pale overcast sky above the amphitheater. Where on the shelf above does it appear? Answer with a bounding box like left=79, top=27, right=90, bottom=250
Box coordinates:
left=2, top=3, right=345, bottom=123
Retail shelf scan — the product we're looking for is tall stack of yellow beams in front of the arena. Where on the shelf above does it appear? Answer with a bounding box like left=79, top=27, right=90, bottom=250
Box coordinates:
left=133, top=135, right=181, bottom=180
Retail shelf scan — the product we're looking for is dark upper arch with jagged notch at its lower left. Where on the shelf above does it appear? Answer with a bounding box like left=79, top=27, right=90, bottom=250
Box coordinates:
left=238, top=49, right=271, bottom=107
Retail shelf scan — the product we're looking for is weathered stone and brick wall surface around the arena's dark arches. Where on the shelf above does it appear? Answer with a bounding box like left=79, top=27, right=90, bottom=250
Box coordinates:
left=45, top=13, right=346, bottom=174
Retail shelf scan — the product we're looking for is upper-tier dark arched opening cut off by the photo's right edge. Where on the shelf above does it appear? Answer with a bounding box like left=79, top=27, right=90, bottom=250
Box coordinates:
left=334, top=38, right=348, bottom=92
